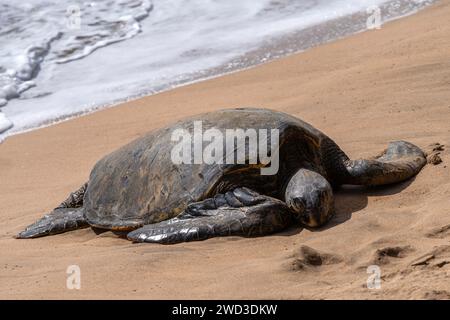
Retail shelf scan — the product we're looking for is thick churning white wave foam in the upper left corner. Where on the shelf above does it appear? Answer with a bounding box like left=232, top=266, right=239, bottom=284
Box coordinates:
left=0, top=0, right=153, bottom=133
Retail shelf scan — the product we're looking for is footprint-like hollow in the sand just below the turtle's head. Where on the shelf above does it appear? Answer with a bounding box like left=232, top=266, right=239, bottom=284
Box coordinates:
left=284, top=245, right=343, bottom=271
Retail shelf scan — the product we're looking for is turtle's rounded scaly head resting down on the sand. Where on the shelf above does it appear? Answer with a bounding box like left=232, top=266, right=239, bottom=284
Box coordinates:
left=285, top=169, right=333, bottom=228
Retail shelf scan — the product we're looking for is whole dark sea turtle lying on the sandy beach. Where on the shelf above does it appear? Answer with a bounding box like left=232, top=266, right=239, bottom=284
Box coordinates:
left=17, top=108, right=426, bottom=244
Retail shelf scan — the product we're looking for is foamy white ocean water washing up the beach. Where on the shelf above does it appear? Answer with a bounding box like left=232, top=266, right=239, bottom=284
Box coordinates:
left=0, top=0, right=433, bottom=140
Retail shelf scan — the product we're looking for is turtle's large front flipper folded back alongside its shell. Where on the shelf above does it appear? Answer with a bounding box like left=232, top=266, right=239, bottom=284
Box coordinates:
left=127, top=188, right=293, bottom=244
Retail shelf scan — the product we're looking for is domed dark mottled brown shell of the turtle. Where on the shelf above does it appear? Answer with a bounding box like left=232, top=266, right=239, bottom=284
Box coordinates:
left=84, top=109, right=327, bottom=230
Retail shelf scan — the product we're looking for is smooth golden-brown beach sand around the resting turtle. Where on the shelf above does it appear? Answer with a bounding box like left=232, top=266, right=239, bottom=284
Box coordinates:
left=0, top=1, right=450, bottom=299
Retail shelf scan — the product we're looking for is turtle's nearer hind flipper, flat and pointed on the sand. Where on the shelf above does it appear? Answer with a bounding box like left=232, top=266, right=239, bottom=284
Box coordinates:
left=16, top=208, right=88, bottom=239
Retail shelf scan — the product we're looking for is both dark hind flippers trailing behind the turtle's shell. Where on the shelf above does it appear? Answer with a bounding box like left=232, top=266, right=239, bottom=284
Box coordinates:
left=16, top=183, right=88, bottom=239
